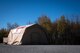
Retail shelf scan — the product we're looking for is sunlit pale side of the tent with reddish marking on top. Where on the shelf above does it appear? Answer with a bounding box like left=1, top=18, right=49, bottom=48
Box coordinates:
left=8, top=24, right=34, bottom=45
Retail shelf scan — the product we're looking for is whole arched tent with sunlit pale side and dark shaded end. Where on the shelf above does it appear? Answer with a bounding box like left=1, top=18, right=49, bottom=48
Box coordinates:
left=8, top=24, right=49, bottom=45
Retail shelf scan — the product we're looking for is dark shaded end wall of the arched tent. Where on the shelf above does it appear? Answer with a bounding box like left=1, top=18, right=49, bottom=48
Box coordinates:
left=21, top=24, right=49, bottom=45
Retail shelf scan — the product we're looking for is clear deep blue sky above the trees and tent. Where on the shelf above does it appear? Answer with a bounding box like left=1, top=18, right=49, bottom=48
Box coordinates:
left=0, top=0, right=80, bottom=28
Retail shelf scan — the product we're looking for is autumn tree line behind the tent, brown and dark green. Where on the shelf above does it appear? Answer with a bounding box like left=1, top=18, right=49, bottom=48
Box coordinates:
left=0, top=15, right=80, bottom=45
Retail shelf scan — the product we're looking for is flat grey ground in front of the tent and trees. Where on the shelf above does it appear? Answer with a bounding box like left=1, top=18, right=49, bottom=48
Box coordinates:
left=0, top=44, right=80, bottom=53
